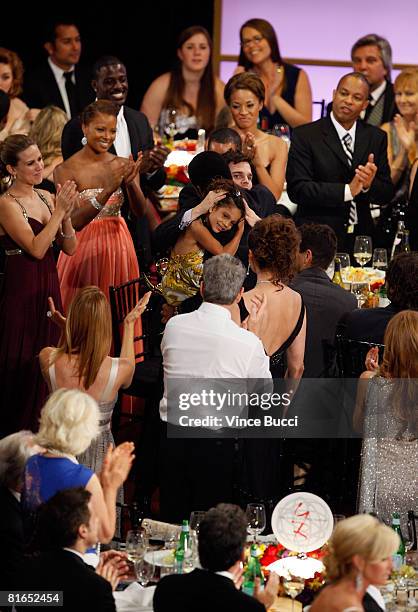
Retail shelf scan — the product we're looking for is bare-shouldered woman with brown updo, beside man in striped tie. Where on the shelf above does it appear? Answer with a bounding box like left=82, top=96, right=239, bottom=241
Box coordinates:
left=224, top=72, right=287, bottom=200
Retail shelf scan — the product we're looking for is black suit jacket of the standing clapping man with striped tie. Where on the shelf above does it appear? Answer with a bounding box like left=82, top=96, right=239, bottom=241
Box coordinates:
left=286, top=117, right=393, bottom=242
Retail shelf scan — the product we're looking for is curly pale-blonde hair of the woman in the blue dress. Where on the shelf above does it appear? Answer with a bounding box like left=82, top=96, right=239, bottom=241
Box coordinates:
left=35, top=389, right=99, bottom=455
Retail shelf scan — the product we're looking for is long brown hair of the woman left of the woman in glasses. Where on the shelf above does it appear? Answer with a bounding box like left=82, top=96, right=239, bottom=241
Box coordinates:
left=163, top=26, right=216, bottom=131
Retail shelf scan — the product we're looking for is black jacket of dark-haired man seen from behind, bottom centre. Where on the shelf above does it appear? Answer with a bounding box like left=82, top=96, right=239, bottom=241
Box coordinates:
left=153, top=569, right=265, bottom=612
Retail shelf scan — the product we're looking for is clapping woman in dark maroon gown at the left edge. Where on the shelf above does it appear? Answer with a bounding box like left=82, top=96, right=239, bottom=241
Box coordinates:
left=0, top=135, right=78, bottom=436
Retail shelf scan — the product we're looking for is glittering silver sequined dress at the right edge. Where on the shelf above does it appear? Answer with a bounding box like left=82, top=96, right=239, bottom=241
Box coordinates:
left=358, top=376, right=418, bottom=533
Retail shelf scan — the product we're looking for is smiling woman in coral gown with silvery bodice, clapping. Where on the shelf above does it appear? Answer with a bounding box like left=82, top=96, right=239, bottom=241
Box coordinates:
left=54, top=100, right=146, bottom=312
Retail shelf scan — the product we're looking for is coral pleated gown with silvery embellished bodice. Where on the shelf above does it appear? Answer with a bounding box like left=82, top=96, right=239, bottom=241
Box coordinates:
left=57, top=188, right=139, bottom=312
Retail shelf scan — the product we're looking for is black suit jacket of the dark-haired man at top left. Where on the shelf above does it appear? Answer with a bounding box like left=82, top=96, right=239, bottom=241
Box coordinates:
left=22, top=60, right=95, bottom=112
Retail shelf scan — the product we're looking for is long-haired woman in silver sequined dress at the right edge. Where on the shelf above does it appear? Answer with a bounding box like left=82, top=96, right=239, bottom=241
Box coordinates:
left=354, top=310, right=418, bottom=533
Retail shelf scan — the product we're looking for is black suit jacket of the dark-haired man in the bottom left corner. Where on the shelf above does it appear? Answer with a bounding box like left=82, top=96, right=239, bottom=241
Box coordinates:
left=20, top=550, right=116, bottom=612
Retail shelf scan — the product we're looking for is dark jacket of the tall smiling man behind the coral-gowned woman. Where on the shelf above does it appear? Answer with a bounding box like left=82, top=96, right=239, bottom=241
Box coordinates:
left=61, top=106, right=165, bottom=190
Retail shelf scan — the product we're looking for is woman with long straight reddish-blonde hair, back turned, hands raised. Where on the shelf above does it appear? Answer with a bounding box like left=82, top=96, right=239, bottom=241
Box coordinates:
left=39, top=287, right=151, bottom=472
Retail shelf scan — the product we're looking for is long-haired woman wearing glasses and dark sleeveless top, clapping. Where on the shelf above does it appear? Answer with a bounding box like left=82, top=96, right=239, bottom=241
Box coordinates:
left=236, top=19, right=312, bottom=130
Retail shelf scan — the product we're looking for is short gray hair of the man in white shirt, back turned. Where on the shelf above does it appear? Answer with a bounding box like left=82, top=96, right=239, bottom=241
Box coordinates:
left=202, top=253, right=246, bottom=306
